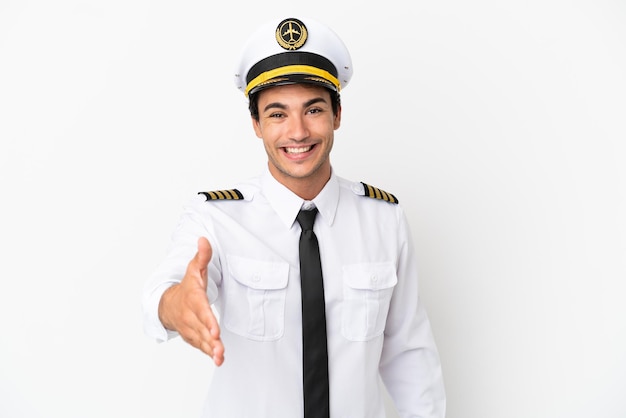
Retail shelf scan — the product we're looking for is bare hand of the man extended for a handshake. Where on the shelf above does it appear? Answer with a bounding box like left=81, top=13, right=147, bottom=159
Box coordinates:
left=159, top=237, right=224, bottom=366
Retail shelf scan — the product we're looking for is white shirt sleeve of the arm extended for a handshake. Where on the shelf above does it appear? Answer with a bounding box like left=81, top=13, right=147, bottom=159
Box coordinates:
left=142, top=198, right=219, bottom=342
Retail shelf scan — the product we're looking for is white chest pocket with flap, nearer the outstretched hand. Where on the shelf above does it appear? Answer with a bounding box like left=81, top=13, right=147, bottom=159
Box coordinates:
left=223, top=256, right=289, bottom=341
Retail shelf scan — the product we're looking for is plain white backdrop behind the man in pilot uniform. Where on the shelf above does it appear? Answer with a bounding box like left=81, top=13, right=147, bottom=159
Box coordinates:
left=0, top=0, right=626, bottom=418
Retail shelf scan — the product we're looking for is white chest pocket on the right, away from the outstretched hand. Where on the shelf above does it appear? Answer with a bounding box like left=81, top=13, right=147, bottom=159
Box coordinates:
left=341, top=263, right=398, bottom=341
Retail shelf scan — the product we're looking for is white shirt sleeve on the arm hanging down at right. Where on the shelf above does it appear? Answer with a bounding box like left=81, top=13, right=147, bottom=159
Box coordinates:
left=380, top=208, right=446, bottom=418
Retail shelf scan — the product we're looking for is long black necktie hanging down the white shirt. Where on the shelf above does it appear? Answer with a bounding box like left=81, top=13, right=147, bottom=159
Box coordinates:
left=296, top=208, right=329, bottom=418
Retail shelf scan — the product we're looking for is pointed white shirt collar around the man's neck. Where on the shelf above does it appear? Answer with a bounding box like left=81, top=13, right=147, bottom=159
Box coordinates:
left=261, top=168, right=339, bottom=228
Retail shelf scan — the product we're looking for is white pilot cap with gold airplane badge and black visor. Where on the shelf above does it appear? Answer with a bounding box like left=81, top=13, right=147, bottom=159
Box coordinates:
left=235, top=18, right=352, bottom=97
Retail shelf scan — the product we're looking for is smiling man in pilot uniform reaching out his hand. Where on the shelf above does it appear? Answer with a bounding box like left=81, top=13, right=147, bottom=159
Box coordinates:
left=144, top=14, right=445, bottom=418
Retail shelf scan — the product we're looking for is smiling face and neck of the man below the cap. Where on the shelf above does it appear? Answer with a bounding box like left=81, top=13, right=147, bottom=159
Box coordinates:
left=252, top=84, right=341, bottom=200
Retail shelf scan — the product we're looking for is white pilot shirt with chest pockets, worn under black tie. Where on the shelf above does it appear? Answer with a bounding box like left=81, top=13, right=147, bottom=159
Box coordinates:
left=143, top=170, right=445, bottom=418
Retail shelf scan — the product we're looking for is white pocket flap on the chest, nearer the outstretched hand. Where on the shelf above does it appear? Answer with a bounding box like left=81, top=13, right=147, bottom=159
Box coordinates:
left=227, top=255, right=289, bottom=290
